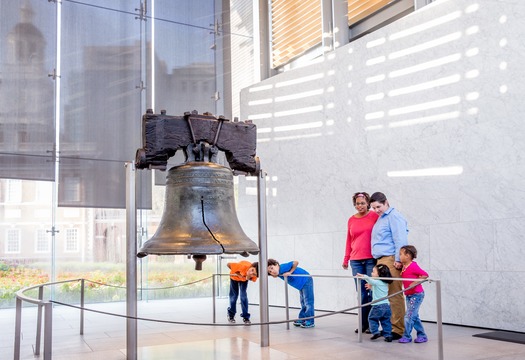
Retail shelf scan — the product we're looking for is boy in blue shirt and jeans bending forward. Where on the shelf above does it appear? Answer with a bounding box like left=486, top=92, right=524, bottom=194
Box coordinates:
left=268, top=259, right=315, bottom=328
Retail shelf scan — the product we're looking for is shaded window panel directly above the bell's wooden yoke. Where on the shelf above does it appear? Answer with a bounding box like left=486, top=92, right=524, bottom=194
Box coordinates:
left=147, top=0, right=215, bottom=115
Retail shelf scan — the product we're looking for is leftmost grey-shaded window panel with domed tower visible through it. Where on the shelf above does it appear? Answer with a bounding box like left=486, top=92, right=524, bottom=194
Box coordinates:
left=0, top=0, right=56, bottom=180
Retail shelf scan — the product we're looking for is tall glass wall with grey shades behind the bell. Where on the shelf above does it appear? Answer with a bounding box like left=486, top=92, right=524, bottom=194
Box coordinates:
left=0, top=0, right=239, bottom=308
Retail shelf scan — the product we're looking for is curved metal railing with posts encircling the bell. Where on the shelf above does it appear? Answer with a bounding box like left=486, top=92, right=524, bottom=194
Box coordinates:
left=14, top=274, right=444, bottom=360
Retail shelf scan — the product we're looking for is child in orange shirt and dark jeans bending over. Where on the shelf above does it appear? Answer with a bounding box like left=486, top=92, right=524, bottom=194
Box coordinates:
left=226, top=261, right=259, bottom=325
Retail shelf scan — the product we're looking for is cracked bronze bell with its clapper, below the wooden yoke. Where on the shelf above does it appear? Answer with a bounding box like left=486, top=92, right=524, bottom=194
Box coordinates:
left=137, top=161, right=259, bottom=270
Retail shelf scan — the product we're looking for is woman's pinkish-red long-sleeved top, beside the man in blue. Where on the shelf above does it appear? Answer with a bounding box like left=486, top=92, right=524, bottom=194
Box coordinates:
left=343, top=211, right=378, bottom=265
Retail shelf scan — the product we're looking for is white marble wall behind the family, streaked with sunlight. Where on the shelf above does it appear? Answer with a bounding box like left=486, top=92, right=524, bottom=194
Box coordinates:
left=238, top=0, right=525, bottom=331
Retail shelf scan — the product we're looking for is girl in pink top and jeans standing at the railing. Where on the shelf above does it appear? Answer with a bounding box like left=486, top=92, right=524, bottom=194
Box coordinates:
left=399, top=245, right=428, bottom=344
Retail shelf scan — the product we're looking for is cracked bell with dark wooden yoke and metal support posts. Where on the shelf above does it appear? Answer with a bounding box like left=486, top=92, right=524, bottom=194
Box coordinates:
left=126, top=109, right=269, bottom=360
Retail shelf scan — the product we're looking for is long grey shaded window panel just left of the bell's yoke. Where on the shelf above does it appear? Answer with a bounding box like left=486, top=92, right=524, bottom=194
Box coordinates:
left=59, top=0, right=149, bottom=208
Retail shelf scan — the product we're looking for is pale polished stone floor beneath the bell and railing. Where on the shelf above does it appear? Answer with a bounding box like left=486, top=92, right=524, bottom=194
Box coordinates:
left=0, top=298, right=525, bottom=360
